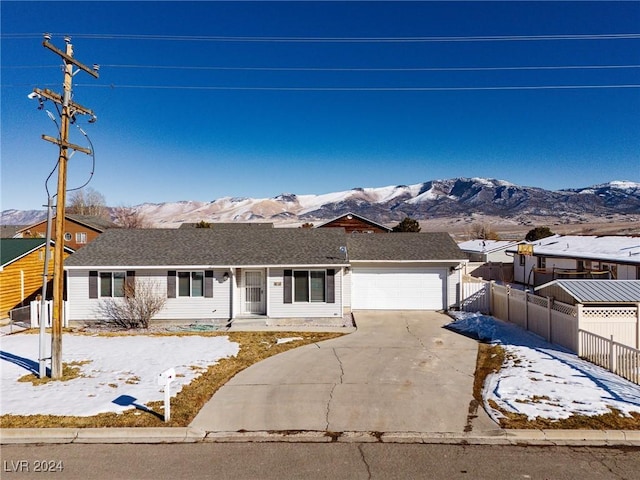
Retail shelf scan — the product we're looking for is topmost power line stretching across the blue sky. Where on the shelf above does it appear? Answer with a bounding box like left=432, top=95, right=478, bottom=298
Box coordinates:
left=5, top=33, right=640, bottom=43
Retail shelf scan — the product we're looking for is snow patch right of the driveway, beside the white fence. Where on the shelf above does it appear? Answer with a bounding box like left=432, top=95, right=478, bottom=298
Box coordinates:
left=449, top=312, right=640, bottom=421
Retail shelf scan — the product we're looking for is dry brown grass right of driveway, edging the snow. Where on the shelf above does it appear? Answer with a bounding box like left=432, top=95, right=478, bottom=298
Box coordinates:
left=473, top=343, right=640, bottom=430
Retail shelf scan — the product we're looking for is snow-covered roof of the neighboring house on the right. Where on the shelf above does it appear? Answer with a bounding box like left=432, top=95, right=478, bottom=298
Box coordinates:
left=507, top=235, right=640, bottom=264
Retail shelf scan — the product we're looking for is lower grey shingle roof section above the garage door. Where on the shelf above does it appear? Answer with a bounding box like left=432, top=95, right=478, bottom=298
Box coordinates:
left=347, top=232, right=465, bottom=261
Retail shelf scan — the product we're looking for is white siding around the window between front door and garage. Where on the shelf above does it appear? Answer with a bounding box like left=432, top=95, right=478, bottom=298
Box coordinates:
left=267, top=267, right=342, bottom=318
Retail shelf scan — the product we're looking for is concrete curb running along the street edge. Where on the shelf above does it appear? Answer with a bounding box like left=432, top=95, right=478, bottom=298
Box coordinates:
left=0, top=427, right=640, bottom=447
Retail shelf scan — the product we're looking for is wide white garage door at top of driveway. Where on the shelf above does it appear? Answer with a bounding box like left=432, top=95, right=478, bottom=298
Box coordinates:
left=351, top=267, right=447, bottom=310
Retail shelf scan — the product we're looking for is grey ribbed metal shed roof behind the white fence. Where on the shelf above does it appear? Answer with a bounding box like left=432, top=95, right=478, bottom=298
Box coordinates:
left=535, top=280, right=640, bottom=303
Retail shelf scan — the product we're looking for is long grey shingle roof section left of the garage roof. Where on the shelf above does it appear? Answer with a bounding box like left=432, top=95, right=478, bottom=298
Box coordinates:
left=65, top=228, right=346, bottom=268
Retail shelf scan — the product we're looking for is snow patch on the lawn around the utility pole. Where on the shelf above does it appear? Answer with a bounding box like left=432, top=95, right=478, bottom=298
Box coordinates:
left=0, top=334, right=240, bottom=416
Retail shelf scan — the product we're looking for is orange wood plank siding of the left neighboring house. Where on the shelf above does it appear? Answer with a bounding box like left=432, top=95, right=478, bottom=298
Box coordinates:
left=0, top=245, right=69, bottom=318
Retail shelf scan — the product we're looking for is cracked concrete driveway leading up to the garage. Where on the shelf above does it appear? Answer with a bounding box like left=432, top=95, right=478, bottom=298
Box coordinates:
left=190, top=311, right=498, bottom=433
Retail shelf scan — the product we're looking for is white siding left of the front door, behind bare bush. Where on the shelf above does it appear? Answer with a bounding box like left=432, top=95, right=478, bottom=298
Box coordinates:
left=67, top=270, right=231, bottom=321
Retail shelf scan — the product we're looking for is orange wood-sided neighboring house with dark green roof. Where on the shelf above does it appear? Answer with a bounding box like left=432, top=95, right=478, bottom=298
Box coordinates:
left=0, top=238, right=71, bottom=318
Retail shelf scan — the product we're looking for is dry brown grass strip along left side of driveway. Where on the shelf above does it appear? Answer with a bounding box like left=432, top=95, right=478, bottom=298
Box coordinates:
left=0, top=332, right=342, bottom=428
